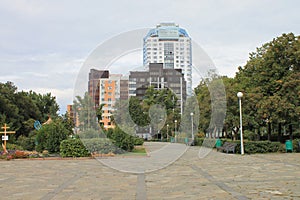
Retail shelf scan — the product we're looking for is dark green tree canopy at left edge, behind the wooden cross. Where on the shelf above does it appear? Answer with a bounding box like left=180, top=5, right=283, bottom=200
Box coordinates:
left=0, top=82, right=59, bottom=137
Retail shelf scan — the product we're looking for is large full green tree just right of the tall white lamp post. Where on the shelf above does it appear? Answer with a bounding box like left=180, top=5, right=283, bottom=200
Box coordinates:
left=235, top=33, right=300, bottom=139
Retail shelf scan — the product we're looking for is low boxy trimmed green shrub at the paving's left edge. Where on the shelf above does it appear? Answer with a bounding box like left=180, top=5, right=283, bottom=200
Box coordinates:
left=60, top=139, right=90, bottom=157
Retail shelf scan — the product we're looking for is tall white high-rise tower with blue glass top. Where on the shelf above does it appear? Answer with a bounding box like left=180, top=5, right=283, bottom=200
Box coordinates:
left=143, top=23, right=193, bottom=96
